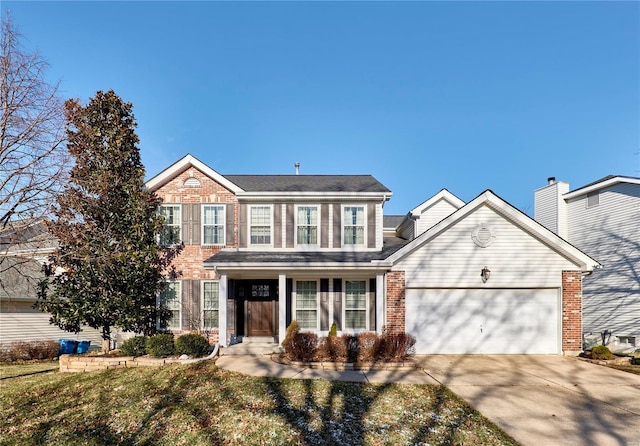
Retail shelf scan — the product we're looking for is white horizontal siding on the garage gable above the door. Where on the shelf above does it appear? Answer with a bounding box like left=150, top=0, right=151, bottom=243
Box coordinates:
left=393, top=206, right=576, bottom=288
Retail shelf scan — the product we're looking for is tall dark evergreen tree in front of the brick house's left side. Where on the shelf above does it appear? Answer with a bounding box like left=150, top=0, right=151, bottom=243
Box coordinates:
left=36, top=90, right=182, bottom=348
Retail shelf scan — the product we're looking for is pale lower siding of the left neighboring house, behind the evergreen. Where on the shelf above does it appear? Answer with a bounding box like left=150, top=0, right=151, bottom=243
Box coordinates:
left=0, top=300, right=102, bottom=347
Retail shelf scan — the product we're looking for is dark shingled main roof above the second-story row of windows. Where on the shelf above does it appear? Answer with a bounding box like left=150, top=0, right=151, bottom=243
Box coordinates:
left=225, top=175, right=391, bottom=194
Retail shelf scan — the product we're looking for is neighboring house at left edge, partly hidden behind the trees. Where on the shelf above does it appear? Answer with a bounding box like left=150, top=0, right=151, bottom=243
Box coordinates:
left=0, top=221, right=101, bottom=345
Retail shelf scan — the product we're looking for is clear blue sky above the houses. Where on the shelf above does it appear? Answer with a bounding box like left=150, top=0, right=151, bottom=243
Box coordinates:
left=1, top=0, right=640, bottom=214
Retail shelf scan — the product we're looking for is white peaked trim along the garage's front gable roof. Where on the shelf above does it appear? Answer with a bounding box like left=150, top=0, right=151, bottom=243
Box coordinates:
left=387, top=190, right=600, bottom=271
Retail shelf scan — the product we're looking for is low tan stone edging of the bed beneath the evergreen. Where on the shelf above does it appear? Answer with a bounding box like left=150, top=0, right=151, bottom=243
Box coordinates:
left=59, top=355, right=181, bottom=373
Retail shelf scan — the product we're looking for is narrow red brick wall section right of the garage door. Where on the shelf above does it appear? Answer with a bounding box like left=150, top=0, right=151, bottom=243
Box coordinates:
left=562, top=271, right=582, bottom=353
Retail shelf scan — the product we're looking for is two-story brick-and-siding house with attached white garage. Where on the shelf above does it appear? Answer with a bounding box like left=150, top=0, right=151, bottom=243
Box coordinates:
left=147, top=155, right=597, bottom=354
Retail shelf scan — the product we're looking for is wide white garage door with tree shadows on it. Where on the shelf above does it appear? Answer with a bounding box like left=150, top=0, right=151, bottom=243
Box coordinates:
left=406, top=289, right=560, bottom=354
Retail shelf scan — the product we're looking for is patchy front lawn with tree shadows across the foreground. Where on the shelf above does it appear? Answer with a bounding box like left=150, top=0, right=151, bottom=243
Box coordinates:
left=0, top=362, right=516, bottom=445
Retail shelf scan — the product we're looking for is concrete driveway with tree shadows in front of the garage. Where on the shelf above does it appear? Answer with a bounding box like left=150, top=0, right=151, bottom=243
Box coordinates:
left=416, top=355, right=640, bottom=446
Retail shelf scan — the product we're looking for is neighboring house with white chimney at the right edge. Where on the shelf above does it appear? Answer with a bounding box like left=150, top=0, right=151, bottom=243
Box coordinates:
left=534, top=175, right=640, bottom=347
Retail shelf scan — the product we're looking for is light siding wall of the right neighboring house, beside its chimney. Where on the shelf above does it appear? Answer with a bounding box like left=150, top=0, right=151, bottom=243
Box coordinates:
left=567, top=183, right=640, bottom=336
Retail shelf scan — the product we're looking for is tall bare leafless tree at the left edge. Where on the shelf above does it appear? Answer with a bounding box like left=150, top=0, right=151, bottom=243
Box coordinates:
left=0, top=14, right=69, bottom=292
